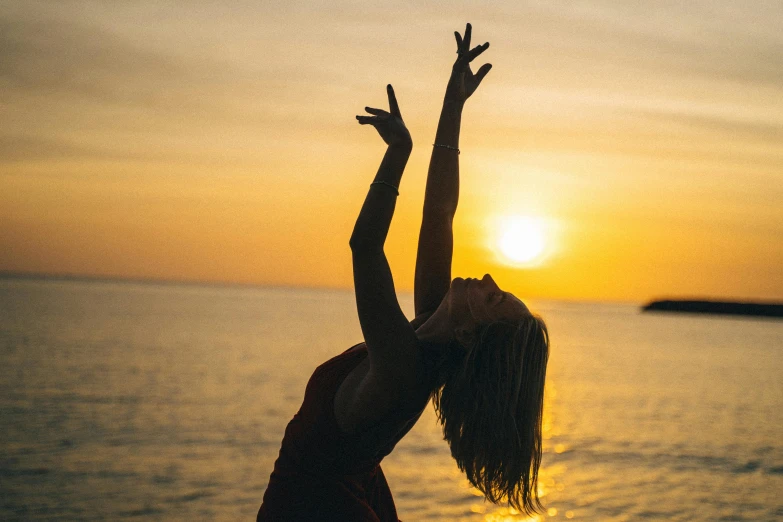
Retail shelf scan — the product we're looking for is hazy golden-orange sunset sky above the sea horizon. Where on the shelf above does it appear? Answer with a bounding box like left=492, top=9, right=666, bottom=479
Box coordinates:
left=0, top=0, right=783, bottom=301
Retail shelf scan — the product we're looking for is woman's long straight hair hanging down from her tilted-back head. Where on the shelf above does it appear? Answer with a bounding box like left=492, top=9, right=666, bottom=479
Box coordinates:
left=432, top=316, right=549, bottom=515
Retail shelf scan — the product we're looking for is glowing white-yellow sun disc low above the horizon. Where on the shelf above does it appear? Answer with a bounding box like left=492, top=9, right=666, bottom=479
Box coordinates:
left=496, top=216, right=547, bottom=266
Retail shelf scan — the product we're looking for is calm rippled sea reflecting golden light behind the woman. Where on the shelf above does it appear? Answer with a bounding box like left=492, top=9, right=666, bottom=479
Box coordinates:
left=0, top=280, right=783, bottom=522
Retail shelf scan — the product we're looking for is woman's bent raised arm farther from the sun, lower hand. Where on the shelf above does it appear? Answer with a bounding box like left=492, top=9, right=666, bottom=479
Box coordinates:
left=350, top=85, right=417, bottom=368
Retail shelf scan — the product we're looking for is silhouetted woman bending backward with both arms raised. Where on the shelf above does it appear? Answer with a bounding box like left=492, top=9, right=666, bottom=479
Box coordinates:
left=258, top=24, right=549, bottom=521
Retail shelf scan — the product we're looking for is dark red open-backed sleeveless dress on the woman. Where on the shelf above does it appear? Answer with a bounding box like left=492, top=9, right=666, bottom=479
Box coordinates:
left=257, top=343, right=427, bottom=522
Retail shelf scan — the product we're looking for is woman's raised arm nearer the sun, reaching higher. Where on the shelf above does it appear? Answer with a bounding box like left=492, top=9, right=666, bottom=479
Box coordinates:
left=414, top=24, right=492, bottom=317
